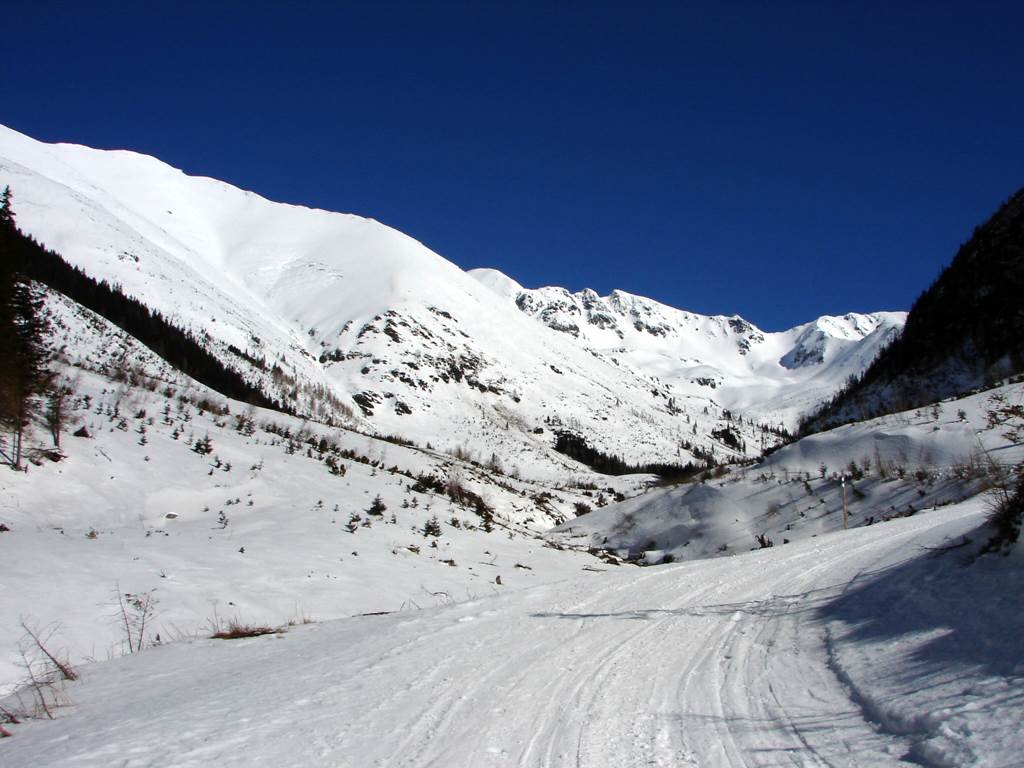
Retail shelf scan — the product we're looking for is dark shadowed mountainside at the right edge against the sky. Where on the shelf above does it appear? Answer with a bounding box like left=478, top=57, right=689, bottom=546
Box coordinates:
left=802, top=189, right=1024, bottom=433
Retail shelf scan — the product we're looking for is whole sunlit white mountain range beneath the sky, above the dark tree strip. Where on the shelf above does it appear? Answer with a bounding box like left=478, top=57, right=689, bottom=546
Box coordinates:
left=0, top=128, right=902, bottom=478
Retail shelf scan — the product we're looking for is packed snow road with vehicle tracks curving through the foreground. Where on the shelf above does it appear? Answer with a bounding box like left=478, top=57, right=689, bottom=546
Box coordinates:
left=0, top=505, right=1024, bottom=768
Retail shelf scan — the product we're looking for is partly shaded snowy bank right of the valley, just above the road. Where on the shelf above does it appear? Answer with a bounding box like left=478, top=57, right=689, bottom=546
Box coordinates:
left=553, top=384, right=1024, bottom=562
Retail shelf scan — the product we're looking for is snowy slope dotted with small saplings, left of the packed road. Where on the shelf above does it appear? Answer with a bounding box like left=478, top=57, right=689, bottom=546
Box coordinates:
left=0, top=295, right=648, bottom=696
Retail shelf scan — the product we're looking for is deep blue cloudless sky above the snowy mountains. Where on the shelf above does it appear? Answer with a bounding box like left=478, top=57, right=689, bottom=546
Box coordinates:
left=0, top=0, right=1024, bottom=330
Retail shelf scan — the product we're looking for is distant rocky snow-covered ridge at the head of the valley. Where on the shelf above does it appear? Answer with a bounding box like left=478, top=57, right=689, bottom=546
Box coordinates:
left=470, top=269, right=905, bottom=426
